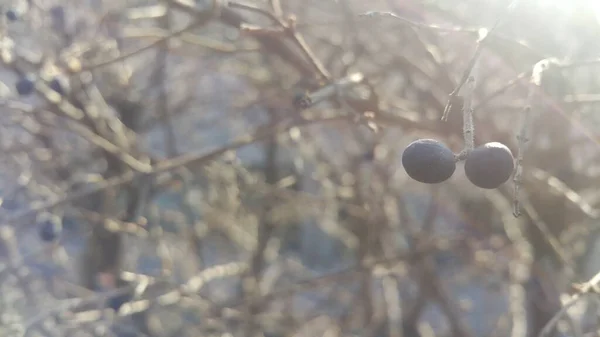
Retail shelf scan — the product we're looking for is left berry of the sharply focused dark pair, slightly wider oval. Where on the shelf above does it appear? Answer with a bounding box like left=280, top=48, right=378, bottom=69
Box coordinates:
left=402, top=139, right=456, bottom=184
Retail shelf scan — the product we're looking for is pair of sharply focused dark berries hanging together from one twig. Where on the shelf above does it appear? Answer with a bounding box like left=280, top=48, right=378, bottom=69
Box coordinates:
left=402, top=139, right=515, bottom=189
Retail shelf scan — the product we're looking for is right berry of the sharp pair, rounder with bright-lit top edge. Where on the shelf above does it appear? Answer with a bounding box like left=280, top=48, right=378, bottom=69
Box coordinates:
left=465, top=142, right=515, bottom=189
